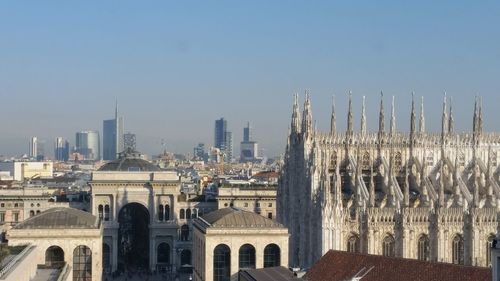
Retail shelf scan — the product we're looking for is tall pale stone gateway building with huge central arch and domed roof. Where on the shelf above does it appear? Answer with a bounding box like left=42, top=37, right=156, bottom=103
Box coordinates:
left=89, top=149, right=216, bottom=273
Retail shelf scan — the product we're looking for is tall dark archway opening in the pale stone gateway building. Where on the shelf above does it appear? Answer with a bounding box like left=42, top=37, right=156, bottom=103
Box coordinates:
left=118, top=203, right=149, bottom=271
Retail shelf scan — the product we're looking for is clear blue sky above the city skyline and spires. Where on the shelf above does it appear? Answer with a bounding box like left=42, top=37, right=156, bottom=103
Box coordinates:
left=0, top=0, right=500, bottom=156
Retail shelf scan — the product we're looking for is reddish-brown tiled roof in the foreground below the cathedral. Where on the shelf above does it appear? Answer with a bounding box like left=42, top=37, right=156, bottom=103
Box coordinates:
left=304, top=250, right=491, bottom=281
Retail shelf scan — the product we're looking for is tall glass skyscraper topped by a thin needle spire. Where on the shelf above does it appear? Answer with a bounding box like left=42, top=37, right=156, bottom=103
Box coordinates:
left=102, top=103, right=124, bottom=160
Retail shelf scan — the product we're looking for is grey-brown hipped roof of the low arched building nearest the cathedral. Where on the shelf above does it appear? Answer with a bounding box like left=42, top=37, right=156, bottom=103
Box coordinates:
left=202, top=207, right=284, bottom=228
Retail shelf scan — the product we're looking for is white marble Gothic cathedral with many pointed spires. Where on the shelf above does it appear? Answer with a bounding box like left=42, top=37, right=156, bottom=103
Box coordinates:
left=277, top=93, right=500, bottom=268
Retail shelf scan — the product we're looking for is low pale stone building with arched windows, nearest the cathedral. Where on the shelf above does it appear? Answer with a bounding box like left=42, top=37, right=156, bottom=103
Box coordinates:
left=193, top=207, right=288, bottom=281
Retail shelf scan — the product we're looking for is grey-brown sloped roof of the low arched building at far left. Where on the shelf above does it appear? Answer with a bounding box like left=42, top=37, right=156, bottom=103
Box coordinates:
left=13, top=207, right=99, bottom=229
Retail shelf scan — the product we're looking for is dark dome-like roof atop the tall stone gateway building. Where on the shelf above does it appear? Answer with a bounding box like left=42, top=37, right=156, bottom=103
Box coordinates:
left=99, top=148, right=160, bottom=172
